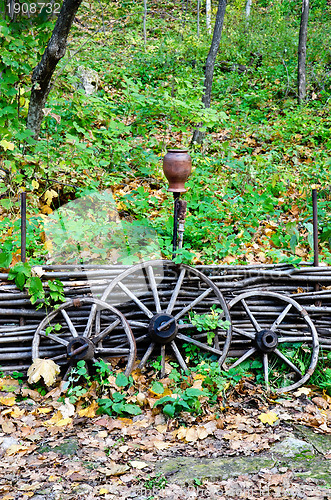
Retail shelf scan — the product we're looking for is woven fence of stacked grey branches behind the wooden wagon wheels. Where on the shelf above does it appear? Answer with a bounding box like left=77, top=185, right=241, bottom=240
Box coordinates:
left=0, top=264, right=331, bottom=372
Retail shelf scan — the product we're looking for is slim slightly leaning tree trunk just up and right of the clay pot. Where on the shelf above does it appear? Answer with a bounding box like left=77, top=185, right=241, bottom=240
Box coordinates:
left=192, top=0, right=226, bottom=144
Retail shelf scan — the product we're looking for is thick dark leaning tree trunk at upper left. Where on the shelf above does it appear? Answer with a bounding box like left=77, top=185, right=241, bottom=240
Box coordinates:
left=27, top=0, right=82, bottom=139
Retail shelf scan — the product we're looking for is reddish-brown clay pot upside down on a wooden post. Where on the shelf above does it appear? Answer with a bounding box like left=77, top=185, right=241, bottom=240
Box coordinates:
left=163, top=149, right=192, bottom=193
